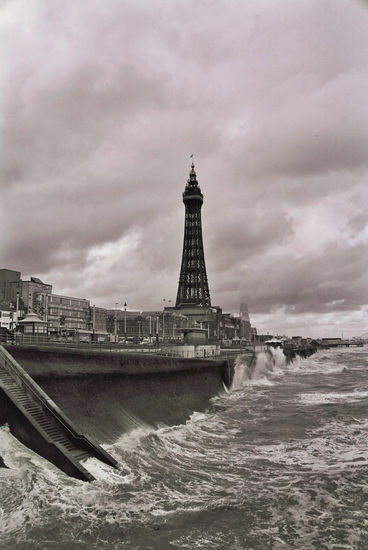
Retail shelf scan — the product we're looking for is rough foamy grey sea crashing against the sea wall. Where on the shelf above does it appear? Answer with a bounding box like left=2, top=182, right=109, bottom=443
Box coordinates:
left=0, top=348, right=368, bottom=550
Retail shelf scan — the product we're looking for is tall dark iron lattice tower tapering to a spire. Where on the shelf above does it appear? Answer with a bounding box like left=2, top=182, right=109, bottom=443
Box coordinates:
left=176, top=163, right=211, bottom=307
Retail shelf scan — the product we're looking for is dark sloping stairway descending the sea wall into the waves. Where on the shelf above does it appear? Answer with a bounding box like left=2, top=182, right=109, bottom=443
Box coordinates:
left=0, top=346, right=117, bottom=481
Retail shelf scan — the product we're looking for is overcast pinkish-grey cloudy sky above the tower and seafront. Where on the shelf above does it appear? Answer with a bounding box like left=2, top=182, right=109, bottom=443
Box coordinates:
left=0, top=0, right=368, bottom=336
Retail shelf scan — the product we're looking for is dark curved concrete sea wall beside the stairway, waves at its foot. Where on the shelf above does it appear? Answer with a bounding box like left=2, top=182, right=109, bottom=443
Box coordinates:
left=2, top=346, right=231, bottom=443
